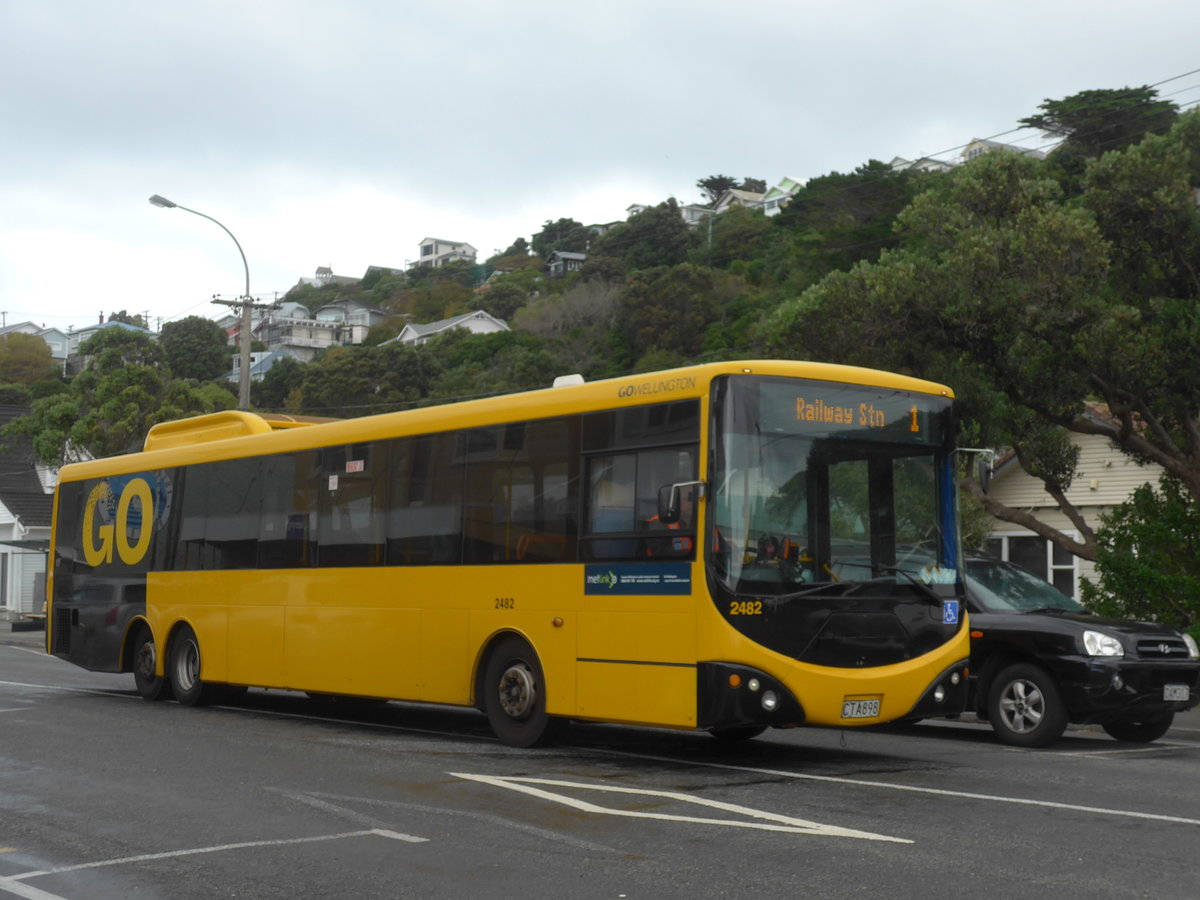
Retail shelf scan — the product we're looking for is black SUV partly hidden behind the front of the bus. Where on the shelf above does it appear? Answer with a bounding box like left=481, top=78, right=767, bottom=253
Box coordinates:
left=966, top=556, right=1200, bottom=746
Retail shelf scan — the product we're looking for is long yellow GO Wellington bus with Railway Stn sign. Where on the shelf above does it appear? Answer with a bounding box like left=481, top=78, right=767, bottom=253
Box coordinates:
left=47, top=361, right=968, bottom=746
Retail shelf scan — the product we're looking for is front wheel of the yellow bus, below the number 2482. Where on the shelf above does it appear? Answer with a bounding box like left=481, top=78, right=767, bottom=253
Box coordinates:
left=482, top=635, right=563, bottom=746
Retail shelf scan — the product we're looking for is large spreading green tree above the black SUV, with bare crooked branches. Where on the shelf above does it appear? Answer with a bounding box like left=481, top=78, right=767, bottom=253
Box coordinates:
left=768, top=112, right=1200, bottom=571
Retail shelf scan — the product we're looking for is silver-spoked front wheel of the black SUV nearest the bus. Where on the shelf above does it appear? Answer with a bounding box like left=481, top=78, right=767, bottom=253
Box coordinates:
left=988, top=662, right=1067, bottom=746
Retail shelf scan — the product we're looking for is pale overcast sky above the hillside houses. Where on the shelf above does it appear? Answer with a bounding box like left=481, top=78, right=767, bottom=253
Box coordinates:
left=0, top=0, right=1200, bottom=330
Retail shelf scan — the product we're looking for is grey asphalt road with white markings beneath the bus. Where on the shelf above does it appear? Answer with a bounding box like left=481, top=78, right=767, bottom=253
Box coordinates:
left=0, top=632, right=1200, bottom=900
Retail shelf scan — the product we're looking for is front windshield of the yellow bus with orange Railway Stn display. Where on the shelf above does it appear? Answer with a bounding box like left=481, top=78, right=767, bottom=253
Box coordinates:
left=710, top=377, right=956, bottom=595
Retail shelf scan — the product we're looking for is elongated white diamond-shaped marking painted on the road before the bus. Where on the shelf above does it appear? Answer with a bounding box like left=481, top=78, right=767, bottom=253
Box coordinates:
left=448, top=772, right=912, bottom=844
